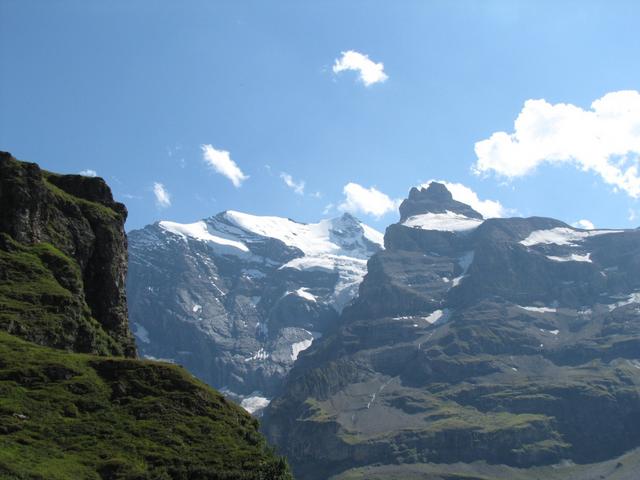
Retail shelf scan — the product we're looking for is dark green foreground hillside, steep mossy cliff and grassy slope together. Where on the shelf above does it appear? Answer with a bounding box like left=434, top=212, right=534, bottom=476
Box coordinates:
left=0, top=153, right=291, bottom=480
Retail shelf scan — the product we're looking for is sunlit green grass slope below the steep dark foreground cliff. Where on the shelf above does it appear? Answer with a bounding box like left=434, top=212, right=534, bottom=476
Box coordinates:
left=0, top=332, right=291, bottom=480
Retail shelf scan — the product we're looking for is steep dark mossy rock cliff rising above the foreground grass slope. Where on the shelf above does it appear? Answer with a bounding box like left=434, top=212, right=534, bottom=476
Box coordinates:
left=0, top=152, right=135, bottom=356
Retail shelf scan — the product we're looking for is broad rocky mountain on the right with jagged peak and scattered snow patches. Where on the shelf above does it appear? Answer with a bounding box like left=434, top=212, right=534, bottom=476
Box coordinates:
left=264, top=182, right=640, bottom=479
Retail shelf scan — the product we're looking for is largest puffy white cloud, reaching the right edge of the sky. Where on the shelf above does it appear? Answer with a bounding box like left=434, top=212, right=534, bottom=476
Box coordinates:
left=474, top=90, right=640, bottom=198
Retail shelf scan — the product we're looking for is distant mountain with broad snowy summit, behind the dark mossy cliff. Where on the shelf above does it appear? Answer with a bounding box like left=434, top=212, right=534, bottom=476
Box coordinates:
left=127, top=211, right=383, bottom=410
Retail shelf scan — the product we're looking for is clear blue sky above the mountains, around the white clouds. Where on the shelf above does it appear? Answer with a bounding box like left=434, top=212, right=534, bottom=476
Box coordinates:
left=0, top=0, right=640, bottom=229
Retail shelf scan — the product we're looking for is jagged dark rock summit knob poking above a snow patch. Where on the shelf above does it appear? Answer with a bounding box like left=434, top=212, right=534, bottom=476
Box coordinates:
left=400, top=182, right=482, bottom=222
